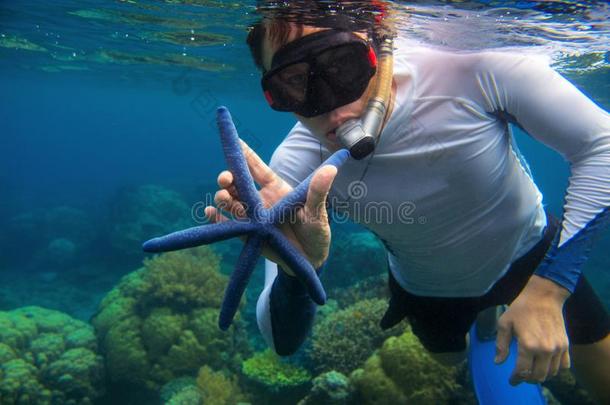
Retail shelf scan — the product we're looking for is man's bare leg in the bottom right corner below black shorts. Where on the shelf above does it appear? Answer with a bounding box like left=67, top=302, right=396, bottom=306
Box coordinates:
left=570, top=335, right=610, bottom=404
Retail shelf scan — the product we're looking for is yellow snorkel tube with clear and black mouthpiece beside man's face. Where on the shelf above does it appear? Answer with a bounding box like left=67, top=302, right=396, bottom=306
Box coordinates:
left=337, top=36, right=394, bottom=160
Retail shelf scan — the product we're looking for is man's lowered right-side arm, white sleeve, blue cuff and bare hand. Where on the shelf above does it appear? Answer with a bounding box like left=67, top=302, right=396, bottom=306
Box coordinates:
left=476, top=50, right=610, bottom=384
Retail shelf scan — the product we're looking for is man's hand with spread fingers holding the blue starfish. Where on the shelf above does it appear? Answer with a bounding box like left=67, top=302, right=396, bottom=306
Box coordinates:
left=205, top=137, right=337, bottom=275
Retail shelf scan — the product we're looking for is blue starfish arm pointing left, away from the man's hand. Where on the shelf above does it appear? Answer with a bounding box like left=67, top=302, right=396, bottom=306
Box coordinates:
left=142, top=221, right=256, bottom=253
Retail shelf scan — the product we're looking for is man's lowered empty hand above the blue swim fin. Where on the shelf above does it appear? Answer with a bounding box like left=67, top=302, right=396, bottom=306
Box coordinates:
left=495, top=275, right=570, bottom=385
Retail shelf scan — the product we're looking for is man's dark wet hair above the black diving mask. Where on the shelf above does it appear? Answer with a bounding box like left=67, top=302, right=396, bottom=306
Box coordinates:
left=246, top=0, right=393, bottom=71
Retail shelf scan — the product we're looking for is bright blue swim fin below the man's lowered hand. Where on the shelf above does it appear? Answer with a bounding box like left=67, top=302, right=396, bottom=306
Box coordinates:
left=468, top=322, right=546, bottom=405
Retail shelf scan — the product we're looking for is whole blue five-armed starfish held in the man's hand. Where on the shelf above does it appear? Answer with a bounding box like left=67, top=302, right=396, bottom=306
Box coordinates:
left=142, top=107, right=349, bottom=330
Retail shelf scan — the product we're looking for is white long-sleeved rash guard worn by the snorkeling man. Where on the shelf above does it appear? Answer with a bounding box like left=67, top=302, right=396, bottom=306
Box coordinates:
left=257, top=37, right=610, bottom=347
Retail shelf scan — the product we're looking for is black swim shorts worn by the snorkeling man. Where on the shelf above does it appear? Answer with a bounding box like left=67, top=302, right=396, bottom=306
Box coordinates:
left=381, top=215, right=610, bottom=353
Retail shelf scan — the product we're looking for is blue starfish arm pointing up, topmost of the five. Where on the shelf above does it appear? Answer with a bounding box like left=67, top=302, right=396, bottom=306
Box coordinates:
left=216, top=107, right=263, bottom=218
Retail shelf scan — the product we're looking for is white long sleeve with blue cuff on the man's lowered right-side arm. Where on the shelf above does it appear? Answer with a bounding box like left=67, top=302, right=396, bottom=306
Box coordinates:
left=477, top=54, right=610, bottom=291
